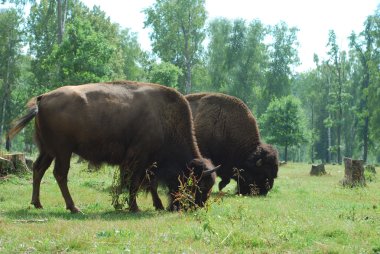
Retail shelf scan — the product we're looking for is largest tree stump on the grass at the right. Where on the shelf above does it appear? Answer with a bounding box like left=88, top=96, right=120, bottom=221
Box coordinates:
left=342, top=158, right=366, bottom=187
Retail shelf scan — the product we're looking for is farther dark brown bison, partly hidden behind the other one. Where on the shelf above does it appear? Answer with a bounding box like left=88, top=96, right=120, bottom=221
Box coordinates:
left=186, top=93, right=278, bottom=195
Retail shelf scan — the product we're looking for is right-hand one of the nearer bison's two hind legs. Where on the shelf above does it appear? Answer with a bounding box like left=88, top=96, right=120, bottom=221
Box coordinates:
left=53, top=154, right=80, bottom=213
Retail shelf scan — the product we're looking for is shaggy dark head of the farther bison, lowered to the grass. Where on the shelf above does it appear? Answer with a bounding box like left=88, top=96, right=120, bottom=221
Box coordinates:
left=238, top=144, right=278, bottom=196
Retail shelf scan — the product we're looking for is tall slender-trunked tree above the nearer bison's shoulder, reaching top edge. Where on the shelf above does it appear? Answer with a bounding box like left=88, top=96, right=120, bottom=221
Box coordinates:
left=144, top=0, right=207, bottom=93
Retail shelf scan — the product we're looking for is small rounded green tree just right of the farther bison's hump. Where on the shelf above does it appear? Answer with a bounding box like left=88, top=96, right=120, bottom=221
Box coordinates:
left=260, top=95, right=307, bottom=161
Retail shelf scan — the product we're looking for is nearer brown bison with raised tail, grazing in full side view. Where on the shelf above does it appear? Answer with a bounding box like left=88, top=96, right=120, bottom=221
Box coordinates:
left=8, top=81, right=216, bottom=213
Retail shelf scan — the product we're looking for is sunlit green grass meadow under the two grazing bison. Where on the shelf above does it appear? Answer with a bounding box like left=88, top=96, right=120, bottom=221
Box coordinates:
left=0, top=162, right=380, bottom=253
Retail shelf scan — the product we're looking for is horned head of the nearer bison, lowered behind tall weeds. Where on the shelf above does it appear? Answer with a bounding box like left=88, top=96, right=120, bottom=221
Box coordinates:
left=188, top=158, right=220, bottom=207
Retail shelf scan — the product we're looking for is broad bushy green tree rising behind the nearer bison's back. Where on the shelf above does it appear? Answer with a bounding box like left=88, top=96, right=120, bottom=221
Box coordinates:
left=28, top=1, right=142, bottom=87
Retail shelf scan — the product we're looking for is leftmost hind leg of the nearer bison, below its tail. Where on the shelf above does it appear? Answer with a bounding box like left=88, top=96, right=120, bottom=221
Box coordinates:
left=30, top=153, right=53, bottom=208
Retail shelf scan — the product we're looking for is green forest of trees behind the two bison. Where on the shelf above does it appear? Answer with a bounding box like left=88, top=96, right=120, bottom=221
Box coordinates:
left=0, top=0, right=380, bottom=163
